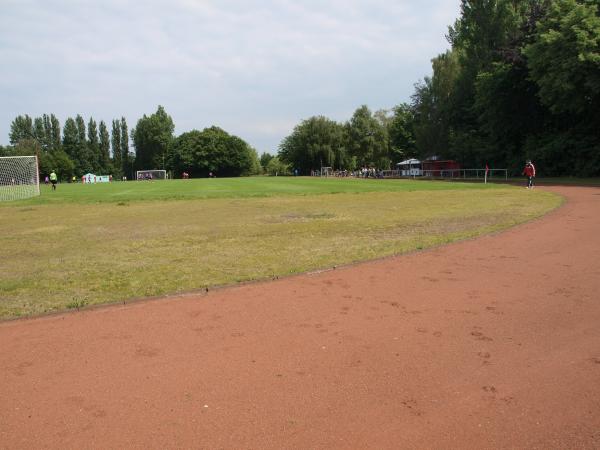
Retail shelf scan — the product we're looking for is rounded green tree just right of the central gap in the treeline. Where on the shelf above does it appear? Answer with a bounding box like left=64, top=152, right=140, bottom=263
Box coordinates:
left=280, top=116, right=351, bottom=173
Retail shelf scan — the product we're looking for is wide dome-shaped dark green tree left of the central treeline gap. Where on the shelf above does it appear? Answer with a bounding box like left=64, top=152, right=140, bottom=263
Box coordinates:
left=168, top=127, right=253, bottom=177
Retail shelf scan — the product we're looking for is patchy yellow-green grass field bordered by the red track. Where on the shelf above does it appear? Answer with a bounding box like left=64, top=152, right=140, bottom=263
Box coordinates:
left=0, top=177, right=562, bottom=318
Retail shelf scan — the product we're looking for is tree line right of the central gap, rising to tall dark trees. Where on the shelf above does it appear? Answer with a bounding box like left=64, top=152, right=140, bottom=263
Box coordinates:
left=278, top=0, right=600, bottom=176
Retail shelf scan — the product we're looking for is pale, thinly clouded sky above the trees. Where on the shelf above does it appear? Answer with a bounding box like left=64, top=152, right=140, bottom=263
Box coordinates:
left=0, top=0, right=460, bottom=154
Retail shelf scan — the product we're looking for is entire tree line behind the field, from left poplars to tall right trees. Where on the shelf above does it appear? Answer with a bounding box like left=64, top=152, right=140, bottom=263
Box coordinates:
left=0, top=0, right=600, bottom=178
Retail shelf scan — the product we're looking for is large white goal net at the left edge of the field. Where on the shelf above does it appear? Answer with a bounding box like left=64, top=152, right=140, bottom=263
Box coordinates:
left=0, top=156, right=40, bottom=202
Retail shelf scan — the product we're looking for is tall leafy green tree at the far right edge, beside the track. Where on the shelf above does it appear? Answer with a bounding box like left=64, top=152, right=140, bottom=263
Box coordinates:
left=523, top=0, right=600, bottom=176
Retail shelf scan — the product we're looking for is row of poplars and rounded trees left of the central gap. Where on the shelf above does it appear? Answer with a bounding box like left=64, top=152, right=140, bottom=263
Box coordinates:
left=0, top=106, right=263, bottom=180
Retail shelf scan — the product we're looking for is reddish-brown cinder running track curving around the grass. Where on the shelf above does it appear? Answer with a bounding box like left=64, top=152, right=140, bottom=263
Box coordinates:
left=0, top=187, right=600, bottom=449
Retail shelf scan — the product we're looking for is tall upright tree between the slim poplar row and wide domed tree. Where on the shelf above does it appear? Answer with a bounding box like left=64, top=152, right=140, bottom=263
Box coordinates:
left=132, top=106, right=175, bottom=169
